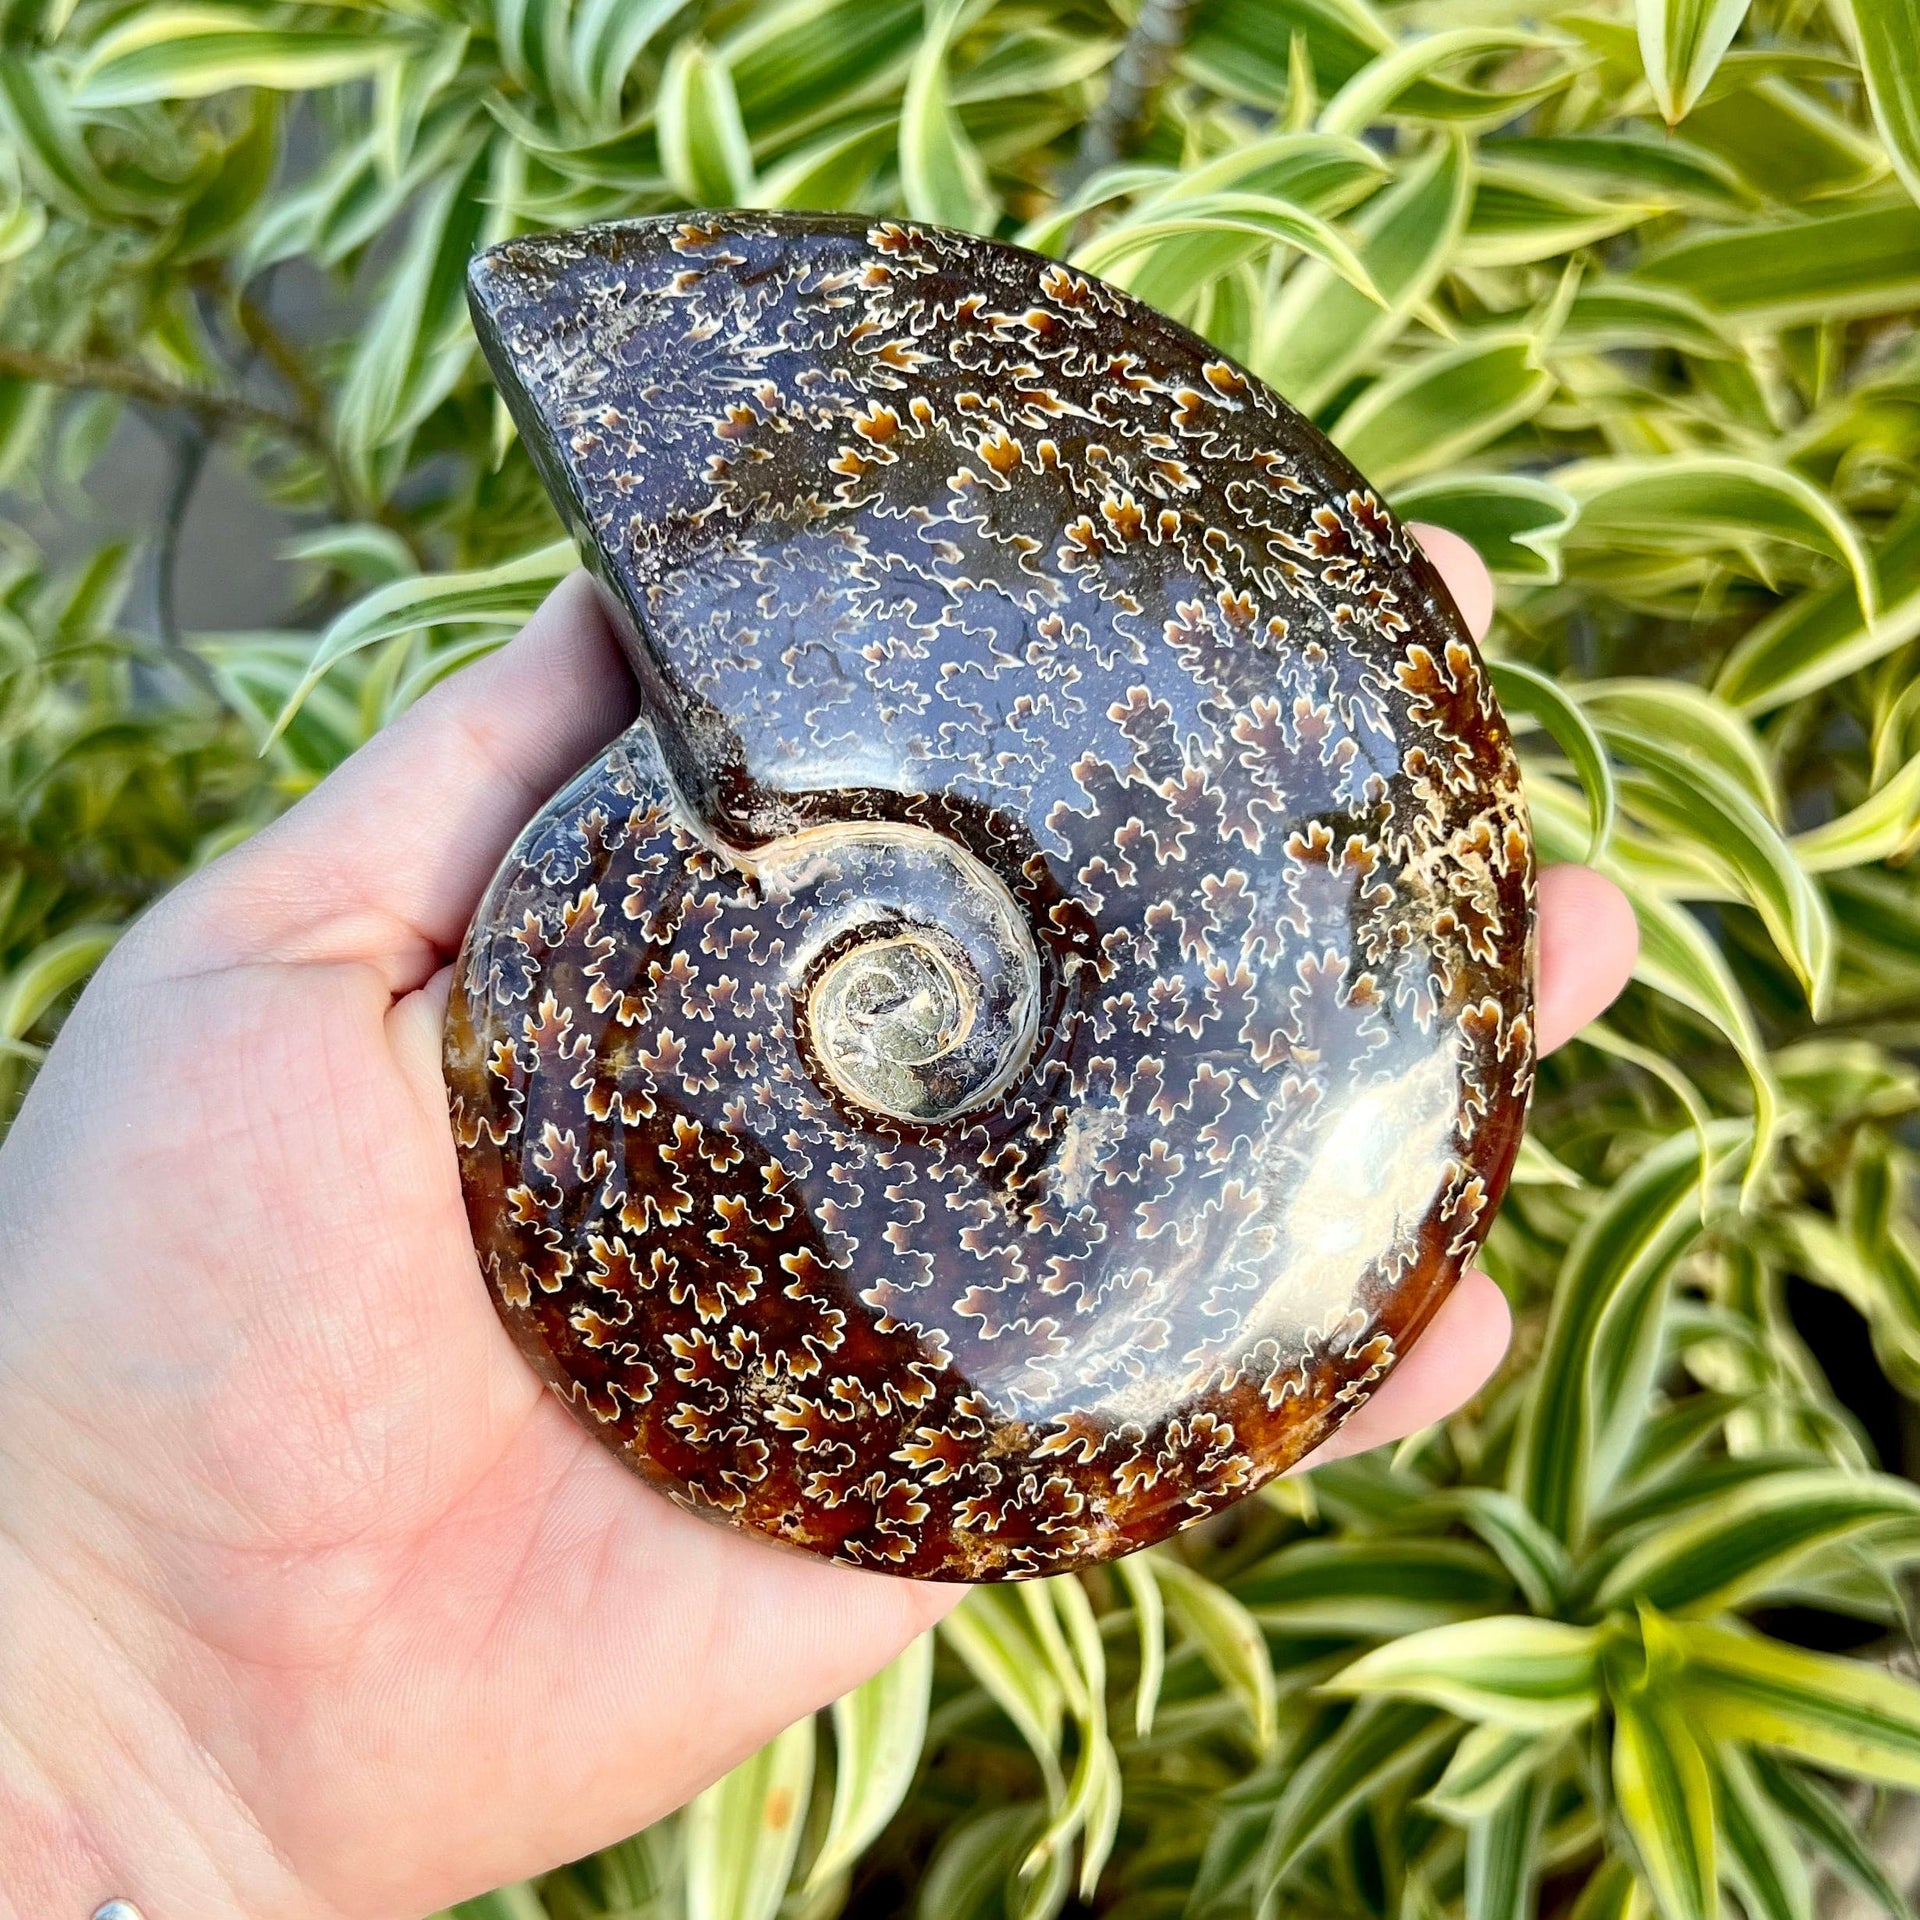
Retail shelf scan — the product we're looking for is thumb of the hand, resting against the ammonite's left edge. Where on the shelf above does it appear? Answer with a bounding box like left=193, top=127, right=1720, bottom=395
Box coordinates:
left=145, top=574, right=634, bottom=993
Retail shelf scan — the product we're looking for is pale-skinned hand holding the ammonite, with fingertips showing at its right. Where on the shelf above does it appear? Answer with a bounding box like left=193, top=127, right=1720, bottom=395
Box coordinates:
left=0, top=530, right=1634, bottom=1920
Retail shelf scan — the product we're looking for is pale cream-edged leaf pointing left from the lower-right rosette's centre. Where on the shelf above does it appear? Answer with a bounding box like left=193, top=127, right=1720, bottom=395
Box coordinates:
left=1325, top=1615, right=1609, bottom=1732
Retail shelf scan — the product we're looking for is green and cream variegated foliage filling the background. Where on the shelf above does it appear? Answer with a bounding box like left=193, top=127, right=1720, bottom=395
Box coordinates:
left=0, top=0, right=1920, bottom=1920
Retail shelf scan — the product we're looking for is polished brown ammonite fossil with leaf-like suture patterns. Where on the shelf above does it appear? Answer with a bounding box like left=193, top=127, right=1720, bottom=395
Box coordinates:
left=447, top=213, right=1532, bottom=1580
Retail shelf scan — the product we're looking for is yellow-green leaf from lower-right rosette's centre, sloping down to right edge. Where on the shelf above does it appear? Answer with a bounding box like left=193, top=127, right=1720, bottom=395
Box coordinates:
left=1674, top=1620, right=1920, bottom=1788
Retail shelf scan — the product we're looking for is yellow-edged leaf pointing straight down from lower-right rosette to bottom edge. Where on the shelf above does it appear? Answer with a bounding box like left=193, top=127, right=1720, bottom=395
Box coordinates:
left=1613, top=1686, right=1720, bottom=1920
